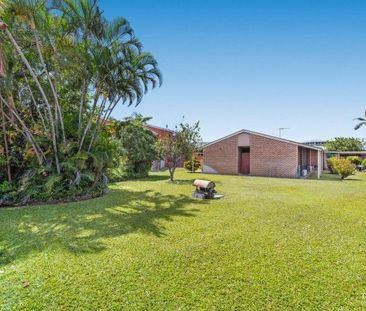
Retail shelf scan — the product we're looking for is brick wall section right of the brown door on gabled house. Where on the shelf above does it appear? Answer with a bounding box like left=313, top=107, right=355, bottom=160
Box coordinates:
left=250, top=135, right=298, bottom=178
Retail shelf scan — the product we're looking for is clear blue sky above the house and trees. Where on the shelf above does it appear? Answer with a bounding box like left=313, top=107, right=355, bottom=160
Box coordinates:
left=100, top=0, right=366, bottom=141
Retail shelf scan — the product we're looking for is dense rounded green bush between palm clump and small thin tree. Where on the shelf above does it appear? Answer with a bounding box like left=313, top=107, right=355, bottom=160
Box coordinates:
left=109, top=115, right=156, bottom=181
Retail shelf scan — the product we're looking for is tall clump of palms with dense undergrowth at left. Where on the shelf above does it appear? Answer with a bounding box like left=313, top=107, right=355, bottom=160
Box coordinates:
left=0, top=0, right=161, bottom=204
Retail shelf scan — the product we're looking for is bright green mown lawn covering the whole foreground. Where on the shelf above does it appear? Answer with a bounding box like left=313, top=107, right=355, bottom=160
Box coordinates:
left=0, top=171, right=366, bottom=310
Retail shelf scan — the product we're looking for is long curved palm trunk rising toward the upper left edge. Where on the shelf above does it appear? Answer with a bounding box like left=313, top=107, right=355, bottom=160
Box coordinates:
left=0, top=20, right=61, bottom=174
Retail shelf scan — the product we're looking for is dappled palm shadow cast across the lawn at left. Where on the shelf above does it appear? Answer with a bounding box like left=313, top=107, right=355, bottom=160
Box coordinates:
left=0, top=189, right=206, bottom=266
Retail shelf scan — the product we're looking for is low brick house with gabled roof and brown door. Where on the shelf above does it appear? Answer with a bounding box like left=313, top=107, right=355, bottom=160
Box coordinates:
left=202, top=130, right=323, bottom=178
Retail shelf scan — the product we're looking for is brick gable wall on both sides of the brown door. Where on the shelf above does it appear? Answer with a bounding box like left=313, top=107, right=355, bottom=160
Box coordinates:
left=203, top=134, right=298, bottom=178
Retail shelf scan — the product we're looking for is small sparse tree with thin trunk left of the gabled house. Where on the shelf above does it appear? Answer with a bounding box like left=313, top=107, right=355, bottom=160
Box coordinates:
left=156, top=122, right=201, bottom=181
